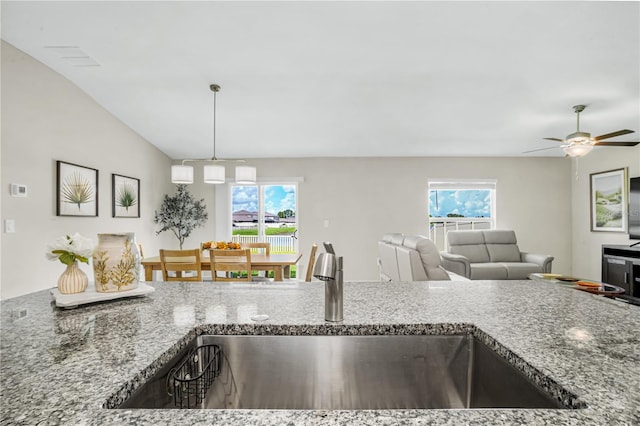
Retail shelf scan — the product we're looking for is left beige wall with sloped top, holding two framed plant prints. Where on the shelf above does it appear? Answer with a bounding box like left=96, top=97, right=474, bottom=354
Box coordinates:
left=0, top=42, right=177, bottom=299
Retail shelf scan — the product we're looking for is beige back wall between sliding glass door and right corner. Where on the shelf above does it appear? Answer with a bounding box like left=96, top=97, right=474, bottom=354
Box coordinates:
left=204, top=157, right=571, bottom=280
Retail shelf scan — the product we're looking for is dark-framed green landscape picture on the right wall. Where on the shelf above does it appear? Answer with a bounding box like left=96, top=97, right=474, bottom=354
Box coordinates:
left=589, top=167, right=629, bottom=232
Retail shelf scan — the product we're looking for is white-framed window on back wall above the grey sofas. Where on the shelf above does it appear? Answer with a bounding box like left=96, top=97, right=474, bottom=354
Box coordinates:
left=428, top=179, right=496, bottom=249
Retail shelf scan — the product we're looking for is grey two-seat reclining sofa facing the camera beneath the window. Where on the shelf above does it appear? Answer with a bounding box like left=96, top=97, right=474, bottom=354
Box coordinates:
left=441, top=229, right=553, bottom=280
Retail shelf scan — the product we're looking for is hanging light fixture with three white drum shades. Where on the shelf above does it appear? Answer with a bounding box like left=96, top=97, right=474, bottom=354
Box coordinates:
left=171, top=84, right=257, bottom=185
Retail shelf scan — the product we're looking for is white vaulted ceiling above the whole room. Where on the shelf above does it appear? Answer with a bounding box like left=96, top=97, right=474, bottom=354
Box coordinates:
left=1, top=1, right=640, bottom=159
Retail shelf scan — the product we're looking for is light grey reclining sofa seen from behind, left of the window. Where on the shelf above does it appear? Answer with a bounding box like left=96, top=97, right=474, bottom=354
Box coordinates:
left=378, top=234, right=467, bottom=282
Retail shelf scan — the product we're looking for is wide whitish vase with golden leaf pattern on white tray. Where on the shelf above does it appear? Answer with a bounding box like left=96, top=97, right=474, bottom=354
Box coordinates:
left=93, top=232, right=140, bottom=293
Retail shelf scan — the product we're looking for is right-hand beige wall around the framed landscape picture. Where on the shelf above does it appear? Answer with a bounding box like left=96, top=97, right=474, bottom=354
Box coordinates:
left=571, top=145, right=640, bottom=280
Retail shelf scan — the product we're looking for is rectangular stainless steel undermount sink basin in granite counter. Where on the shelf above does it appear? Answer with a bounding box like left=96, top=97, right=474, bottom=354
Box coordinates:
left=118, top=335, right=566, bottom=410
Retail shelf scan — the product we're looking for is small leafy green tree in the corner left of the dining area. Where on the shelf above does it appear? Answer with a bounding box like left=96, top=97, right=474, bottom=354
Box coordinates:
left=153, top=184, right=207, bottom=250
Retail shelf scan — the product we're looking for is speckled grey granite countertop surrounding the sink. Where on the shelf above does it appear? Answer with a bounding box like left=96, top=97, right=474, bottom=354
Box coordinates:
left=0, top=281, right=640, bottom=425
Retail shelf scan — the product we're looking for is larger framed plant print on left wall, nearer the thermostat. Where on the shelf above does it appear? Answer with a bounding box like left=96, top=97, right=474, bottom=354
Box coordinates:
left=56, top=161, right=98, bottom=217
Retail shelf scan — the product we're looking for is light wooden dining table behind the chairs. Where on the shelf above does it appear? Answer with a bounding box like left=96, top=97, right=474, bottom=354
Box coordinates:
left=141, top=253, right=302, bottom=281
